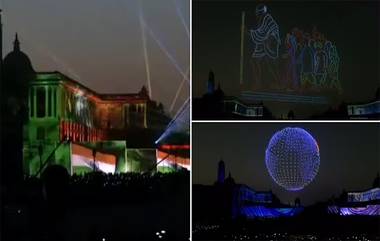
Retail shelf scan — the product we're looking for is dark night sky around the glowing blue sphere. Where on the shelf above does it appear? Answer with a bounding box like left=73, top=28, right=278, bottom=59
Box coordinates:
left=192, top=123, right=380, bottom=205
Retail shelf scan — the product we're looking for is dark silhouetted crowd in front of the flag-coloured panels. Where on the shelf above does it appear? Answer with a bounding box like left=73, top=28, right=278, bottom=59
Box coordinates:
left=3, top=169, right=190, bottom=240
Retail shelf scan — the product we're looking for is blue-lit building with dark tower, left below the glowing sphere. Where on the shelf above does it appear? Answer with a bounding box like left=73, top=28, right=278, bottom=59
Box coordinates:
left=193, top=161, right=304, bottom=220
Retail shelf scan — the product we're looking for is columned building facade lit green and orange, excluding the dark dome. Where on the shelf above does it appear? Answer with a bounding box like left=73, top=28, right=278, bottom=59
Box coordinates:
left=24, top=69, right=164, bottom=174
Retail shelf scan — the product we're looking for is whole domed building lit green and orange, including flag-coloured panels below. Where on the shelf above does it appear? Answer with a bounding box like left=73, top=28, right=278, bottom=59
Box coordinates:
left=2, top=31, right=190, bottom=176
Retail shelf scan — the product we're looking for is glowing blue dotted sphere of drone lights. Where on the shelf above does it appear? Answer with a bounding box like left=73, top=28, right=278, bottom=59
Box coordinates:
left=265, top=127, right=320, bottom=191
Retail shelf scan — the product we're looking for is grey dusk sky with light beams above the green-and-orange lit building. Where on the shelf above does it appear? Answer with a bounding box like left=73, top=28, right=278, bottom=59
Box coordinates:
left=0, top=0, right=190, bottom=115
